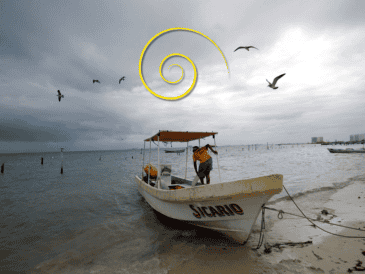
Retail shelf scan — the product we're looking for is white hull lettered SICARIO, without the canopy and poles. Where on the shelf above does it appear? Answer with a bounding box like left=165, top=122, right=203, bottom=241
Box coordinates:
left=136, top=175, right=282, bottom=244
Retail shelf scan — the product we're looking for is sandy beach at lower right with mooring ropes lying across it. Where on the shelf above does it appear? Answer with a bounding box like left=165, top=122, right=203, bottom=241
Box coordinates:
left=168, top=181, right=365, bottom=274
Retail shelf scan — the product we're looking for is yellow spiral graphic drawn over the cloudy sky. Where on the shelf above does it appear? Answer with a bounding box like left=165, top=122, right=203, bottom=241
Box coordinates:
left=139, top=28, right=229, bottom=100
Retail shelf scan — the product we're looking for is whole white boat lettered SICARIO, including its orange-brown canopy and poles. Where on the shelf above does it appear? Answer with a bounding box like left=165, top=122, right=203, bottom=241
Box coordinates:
left=135, top=131, right=283, bottom=244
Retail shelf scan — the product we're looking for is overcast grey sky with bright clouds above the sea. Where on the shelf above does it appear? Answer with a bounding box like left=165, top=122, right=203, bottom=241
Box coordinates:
left=0, top=0, right=365, bottom=153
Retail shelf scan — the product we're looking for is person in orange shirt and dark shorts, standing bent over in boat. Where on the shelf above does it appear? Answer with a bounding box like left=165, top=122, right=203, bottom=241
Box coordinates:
left=193, top=144, right=218, bottom=185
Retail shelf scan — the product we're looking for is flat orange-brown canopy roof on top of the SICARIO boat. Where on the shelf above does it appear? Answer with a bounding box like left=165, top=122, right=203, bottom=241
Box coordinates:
left=144, top=130, right=218, bottom=142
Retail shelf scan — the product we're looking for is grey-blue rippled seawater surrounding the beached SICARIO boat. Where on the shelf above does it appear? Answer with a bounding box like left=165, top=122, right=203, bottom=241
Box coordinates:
left=0, top=145, right=365, bottom=273
